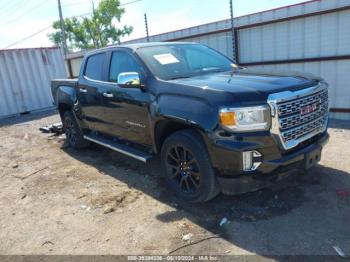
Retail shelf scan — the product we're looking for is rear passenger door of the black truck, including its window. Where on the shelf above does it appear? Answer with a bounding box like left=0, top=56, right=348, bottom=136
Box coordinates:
left=77, top=52, right=110, bottom=132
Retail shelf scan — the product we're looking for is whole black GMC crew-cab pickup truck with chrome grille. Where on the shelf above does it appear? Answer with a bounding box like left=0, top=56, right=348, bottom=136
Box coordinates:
left=52, top=42, right=329, bottom=202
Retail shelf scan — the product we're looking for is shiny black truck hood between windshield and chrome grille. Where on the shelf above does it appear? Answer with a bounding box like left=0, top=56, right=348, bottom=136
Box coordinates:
left=169, top=69, right=322, bottom=102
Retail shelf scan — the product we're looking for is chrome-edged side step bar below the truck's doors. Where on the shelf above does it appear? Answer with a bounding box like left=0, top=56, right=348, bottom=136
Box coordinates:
left=84, top=135, right=152, bottom=163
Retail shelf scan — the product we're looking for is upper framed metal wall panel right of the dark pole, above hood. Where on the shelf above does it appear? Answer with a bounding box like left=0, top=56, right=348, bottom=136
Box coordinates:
left=239, top=8, right=350, bottom=63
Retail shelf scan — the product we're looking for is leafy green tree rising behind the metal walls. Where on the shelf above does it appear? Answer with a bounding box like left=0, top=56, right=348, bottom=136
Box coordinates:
left=48, top=0, right=133, bottom=51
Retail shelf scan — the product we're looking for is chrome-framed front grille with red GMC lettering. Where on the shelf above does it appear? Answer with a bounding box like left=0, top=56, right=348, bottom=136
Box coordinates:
left=269, top=86, right=328, bottom=149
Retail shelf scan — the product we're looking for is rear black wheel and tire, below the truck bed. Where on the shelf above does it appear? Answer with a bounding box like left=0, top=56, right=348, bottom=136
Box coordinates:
left=62, top=111, right=89, bottom=149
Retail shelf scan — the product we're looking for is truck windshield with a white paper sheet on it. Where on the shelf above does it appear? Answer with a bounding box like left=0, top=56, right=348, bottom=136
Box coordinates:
left=137, top=44, right=232, bottom=80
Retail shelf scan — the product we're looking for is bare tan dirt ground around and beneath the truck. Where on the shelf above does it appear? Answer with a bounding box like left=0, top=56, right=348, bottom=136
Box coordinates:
left=0, top=111, right=350, bottom=257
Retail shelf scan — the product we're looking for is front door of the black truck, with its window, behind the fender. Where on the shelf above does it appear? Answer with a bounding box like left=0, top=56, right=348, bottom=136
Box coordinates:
left=99, top=50, right=152, bottom=145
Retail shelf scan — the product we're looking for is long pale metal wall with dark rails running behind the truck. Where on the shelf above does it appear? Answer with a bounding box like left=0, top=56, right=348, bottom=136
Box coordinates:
left=64, top=0, right=350, bottom=119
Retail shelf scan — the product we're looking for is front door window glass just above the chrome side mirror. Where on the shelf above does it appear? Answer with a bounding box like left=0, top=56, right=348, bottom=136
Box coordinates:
left=109, top=51, right=142, bottom=83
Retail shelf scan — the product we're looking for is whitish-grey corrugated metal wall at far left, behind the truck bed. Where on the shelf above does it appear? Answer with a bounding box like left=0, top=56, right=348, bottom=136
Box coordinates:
left=0, top=48, right=67, bottom=118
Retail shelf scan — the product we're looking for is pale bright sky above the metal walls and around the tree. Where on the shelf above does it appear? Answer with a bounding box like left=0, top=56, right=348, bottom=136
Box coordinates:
left=0, top=0, right=306, bottom=49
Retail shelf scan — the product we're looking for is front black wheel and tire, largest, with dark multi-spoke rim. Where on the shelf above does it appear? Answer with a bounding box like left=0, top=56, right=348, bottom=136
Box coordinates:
left=161, top=130, right=219, bottom=202
